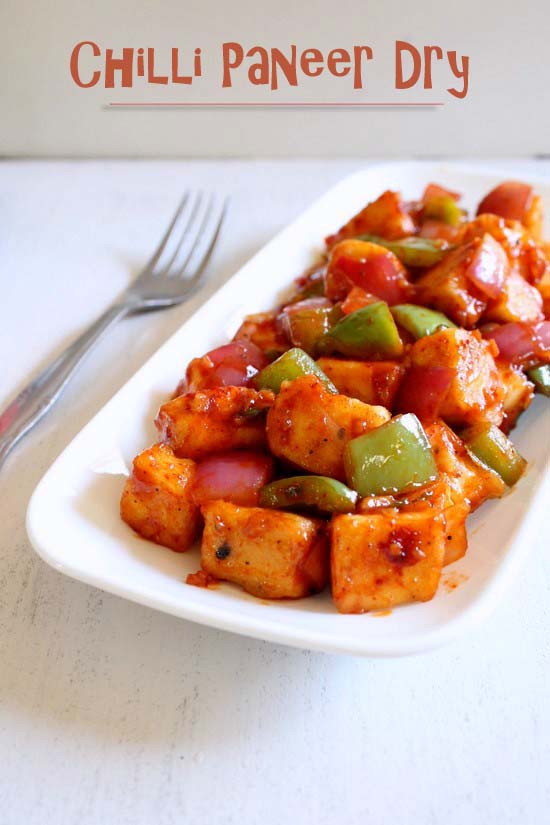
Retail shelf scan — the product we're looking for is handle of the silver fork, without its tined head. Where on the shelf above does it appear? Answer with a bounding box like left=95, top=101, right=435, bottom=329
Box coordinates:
left=0, top=304, right=130, bottom=466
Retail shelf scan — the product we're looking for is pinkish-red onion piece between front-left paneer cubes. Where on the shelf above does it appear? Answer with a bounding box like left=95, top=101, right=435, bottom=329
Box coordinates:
left=193, top=450, right=273, bottom=507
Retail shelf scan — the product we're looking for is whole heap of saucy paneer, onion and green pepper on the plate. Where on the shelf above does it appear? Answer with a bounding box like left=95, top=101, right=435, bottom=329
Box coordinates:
left=121, top=181, right=550, bottom=613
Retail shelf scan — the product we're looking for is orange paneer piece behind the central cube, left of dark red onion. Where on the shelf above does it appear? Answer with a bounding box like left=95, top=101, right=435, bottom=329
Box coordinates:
left=317, top=358, right=405, bottom=410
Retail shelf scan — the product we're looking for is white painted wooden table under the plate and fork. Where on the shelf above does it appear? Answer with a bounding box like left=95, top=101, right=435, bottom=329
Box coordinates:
left=0, top=161, right=550, bottom=825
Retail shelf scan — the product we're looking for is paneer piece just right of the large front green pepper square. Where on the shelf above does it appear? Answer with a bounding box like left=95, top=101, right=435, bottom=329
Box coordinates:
left=425, top=420, right=506, bottom=512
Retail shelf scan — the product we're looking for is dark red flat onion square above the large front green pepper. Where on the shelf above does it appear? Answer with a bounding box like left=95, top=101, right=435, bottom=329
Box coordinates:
left=397, top=365, right=456, bottom=424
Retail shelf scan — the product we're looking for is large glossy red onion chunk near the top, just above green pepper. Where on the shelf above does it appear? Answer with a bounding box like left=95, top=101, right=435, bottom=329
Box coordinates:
left=326, top=240, right=411, bottom=304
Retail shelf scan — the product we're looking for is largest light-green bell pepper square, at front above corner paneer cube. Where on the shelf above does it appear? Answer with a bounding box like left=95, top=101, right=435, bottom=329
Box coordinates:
left=344, top=413, right=439, bottom=496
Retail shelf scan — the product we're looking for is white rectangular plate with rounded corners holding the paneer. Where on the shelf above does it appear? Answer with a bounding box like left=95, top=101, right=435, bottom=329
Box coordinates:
left=27, top=162, right=550, bottom=656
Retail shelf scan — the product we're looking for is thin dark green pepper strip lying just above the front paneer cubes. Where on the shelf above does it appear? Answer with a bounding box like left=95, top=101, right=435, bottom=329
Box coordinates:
left=260, top=476, right=357, bottom=513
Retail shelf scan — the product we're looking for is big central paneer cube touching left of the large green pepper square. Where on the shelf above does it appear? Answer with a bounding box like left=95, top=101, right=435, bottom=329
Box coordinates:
left=267, top=375, right=390, bottom=480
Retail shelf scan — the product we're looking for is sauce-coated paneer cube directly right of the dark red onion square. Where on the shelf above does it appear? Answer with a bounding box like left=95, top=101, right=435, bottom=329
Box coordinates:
left=410, top=329, right=504, bottom=426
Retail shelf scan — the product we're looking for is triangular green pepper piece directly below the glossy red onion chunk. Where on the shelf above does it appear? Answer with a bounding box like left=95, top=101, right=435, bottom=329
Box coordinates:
left=319, top=301, right=403, bottom=359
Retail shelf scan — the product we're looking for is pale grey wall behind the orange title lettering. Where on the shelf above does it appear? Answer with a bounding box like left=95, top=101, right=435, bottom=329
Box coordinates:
left=0, top=0, right=550, bottom=157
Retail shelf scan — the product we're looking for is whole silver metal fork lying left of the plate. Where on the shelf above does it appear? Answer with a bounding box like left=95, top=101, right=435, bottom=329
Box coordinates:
left=0, top=192, right=226, bottom=466
